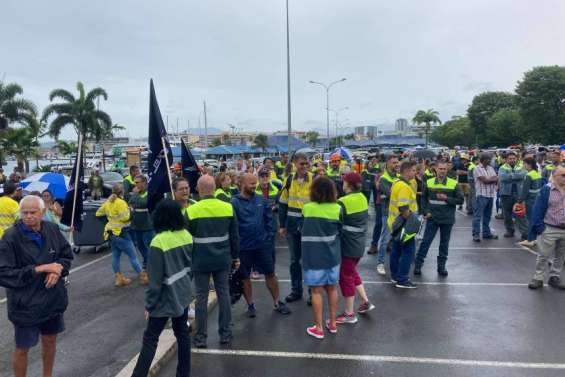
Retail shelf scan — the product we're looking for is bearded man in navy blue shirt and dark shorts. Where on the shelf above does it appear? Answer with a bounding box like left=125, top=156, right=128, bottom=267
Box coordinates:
left=232, top=174, right=290, bottom=318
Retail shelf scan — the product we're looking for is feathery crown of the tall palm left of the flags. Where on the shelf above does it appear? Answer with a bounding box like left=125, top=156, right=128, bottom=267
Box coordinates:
left=42, top=81, right=113, bottom=141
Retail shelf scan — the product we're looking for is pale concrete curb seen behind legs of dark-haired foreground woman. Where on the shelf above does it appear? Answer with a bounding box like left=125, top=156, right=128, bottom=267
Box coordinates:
left=115, top=291, right=218, bottom=377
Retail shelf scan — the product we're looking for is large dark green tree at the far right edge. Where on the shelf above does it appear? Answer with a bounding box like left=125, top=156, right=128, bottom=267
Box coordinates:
left=516, top=66, right=565, bottom=144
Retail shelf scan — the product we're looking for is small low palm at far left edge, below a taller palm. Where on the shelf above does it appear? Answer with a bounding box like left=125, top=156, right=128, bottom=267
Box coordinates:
left=2, top=127, right=39, bottom=172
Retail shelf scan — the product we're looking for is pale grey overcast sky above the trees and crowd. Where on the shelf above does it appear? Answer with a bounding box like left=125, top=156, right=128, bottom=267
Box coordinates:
left=0, top=0, right=565, bottom=137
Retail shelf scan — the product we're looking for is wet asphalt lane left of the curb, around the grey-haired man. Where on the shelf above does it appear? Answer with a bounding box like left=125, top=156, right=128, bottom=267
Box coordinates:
left=0, top=244, right=145, bottom=377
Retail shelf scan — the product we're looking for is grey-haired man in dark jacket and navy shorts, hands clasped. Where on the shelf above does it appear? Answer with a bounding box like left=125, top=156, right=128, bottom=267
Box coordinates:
left=0, top=195, right=73, bottom=377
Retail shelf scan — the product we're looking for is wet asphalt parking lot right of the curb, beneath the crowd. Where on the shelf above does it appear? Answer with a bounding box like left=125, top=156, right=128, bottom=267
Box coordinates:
left=159, top=214, right=565, bottom=377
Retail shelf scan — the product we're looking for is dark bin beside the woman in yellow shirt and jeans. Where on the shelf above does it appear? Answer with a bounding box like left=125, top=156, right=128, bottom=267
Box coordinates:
left=73, top=200, right=108, bottom=253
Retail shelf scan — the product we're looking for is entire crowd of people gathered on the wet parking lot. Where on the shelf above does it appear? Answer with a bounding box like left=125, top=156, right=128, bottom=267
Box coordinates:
left=0, top=145, right=565, bottom=377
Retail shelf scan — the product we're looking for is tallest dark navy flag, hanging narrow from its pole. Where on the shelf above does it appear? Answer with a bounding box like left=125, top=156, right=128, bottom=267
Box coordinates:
left=147, top=80, right=173, bottom=212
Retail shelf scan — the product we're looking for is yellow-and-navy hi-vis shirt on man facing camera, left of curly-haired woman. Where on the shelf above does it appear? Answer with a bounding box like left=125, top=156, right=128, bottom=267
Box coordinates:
left=279, top=172, right=313, bottom=232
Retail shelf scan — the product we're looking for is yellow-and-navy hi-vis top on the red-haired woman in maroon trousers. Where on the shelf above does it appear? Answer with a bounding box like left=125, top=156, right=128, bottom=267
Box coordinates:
left=338, top=192, right=369, bottom=258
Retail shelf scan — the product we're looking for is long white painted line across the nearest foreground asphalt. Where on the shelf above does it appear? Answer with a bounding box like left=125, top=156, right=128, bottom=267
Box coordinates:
left=192, top=348, right=565, bottom=370
